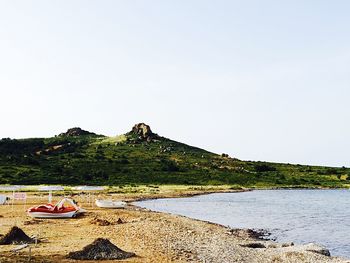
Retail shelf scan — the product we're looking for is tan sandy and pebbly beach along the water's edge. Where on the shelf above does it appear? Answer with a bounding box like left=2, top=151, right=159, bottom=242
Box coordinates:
left=0, top=190, right=350, bottom=263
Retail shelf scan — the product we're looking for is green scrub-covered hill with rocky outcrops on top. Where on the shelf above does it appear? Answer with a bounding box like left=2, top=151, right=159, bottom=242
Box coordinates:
left=0, top=123, right=350, bottom=187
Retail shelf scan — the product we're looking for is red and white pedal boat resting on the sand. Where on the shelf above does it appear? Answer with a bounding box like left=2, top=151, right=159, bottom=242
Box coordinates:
left=27, top=198, right=86, bottom=218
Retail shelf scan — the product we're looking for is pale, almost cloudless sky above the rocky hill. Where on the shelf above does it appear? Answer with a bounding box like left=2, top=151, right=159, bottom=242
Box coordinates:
left=0, top=0, right=350, bottom=166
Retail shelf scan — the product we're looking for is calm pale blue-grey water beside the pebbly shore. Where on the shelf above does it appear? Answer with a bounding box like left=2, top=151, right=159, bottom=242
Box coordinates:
left=136, top=190, right=350, bottom=258
